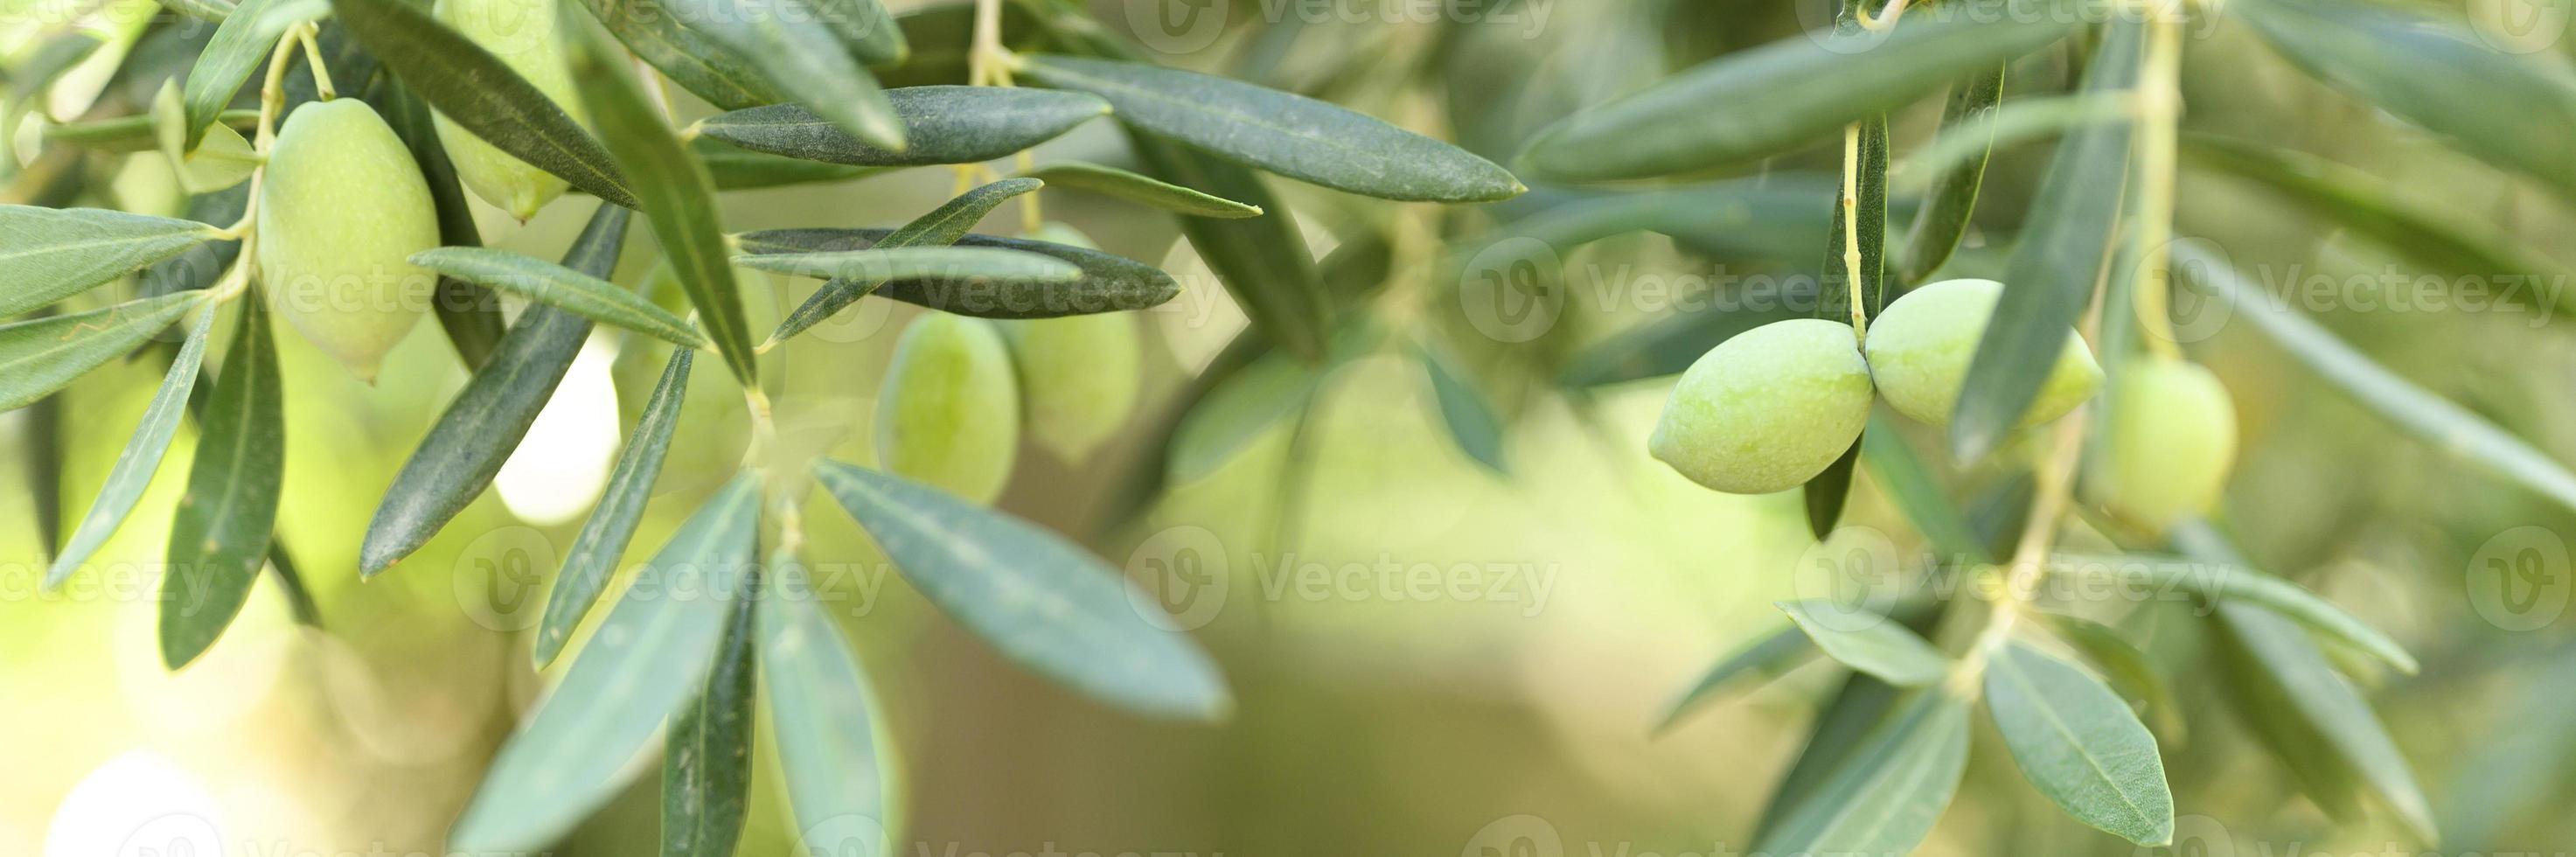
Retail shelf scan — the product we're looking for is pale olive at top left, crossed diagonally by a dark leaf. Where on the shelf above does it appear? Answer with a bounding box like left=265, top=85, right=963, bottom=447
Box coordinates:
left=435, top=0, right=582, bottom=221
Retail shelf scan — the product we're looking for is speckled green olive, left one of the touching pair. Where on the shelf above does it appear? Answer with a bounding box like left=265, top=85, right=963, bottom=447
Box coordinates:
left=1646, top=319, right=1870, bottom=494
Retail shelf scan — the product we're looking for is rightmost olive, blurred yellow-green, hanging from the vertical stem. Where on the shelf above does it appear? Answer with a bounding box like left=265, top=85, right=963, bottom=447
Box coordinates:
left=2099, top=358, right=2236, bottom=530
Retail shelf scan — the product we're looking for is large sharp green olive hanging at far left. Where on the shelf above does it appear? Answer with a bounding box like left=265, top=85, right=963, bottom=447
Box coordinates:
left=258, top=98, right=438, bottom=383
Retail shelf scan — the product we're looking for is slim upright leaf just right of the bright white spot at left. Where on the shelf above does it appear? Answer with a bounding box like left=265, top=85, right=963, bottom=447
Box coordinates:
left=533, top=347, right=695, bottom=669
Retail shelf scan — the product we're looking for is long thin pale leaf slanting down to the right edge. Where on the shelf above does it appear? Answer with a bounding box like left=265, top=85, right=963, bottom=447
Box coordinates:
left=2174, top=242, right=2576, bottom=519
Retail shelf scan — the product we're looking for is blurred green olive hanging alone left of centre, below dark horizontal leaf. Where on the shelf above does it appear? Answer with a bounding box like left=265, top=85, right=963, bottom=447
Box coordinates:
left=876, top=311, right=1020, bottom=502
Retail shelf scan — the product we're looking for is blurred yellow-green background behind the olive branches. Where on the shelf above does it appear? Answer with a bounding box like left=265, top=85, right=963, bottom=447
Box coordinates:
left=15, top=0, right=2576, bottom=857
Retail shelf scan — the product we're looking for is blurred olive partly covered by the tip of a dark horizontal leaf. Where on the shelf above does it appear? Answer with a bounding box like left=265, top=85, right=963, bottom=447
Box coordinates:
left=999, top=224, right=1144, bottom=463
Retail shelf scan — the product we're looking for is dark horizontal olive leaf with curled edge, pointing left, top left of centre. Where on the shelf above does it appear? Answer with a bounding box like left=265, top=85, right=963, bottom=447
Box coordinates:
left=698, top=87, right=1110, bottom=167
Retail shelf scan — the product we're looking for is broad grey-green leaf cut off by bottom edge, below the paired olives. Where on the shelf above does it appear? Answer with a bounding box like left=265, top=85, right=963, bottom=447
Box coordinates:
left=1754, top=690, right=1968, bottom=854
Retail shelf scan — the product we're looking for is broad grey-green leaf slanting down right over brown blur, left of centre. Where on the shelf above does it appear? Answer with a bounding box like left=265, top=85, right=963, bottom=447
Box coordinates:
left=814, top=461, right=1234, bottom=721
